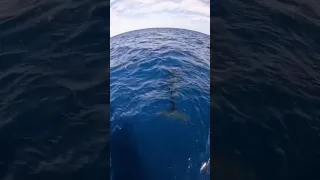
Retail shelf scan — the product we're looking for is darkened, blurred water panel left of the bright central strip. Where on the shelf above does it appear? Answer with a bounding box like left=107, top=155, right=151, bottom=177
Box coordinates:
left=0, top=0, right=110, bottom=180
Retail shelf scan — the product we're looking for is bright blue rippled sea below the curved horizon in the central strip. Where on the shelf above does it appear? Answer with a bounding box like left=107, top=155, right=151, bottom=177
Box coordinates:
left=110, top=28, right=210, bottom=180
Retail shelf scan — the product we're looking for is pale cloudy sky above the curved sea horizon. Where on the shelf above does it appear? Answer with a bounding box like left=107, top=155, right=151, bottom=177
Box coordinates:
left=110, top=0, right=210, bottom=37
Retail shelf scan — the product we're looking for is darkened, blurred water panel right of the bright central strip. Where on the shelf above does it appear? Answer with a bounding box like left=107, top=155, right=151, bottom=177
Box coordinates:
left=211, top=0, right=320, bottom=180
